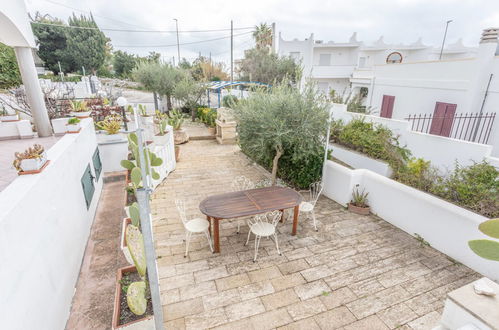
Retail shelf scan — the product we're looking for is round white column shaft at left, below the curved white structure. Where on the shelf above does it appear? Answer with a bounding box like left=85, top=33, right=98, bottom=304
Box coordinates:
left=14, top=47, right=52, bottom=136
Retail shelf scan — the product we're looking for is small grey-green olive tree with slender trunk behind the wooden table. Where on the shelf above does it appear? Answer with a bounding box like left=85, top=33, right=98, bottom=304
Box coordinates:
left=235, top=81, right=328, bottom=184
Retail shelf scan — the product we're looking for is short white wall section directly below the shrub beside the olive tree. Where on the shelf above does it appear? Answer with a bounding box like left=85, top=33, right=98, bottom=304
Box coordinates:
left=330, top=143, right=392, bottom=178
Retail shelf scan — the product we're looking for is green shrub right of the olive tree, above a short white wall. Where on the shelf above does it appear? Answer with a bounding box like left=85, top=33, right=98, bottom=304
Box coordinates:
left=331, top=119, right=411, bottom=170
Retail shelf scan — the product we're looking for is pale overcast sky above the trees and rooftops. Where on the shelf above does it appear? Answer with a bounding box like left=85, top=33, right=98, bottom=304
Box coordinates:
left=26, top=0, right=499, bottom=66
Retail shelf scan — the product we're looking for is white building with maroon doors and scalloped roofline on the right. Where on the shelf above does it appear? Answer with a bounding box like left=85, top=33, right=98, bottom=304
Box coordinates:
left=278, top=29, right=499, bottom=160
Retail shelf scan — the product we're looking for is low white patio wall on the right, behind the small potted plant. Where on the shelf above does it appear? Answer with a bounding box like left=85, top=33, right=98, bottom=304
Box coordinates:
left=323, top=161, right=499, bottom=281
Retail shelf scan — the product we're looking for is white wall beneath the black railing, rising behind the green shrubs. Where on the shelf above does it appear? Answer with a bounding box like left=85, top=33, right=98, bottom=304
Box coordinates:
left=333, top=105, right=499, bottom=171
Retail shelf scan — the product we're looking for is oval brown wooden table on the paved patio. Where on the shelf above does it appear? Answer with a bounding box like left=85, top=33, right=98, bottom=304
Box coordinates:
left=199, top=186, right=303, bottom=252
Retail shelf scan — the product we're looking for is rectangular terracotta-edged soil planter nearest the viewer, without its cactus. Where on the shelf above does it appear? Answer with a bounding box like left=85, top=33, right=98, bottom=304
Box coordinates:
left=112, top=266, right=155, bottom=329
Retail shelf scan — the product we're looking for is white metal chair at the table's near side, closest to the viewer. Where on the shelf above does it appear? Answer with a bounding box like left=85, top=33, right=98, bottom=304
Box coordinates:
left=244, top=211, right=281, bottom=262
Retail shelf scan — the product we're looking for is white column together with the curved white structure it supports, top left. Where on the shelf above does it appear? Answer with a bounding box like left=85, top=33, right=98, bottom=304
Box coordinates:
left=0, top=0, right=52, bottom=136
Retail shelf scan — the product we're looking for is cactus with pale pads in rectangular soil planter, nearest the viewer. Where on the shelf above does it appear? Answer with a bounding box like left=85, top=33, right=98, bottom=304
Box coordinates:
left=113, top=224, right=154, bottom=329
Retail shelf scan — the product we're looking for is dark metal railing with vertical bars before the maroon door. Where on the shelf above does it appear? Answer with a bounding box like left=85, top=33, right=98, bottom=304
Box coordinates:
left=405, top=112, right=496, bottom=144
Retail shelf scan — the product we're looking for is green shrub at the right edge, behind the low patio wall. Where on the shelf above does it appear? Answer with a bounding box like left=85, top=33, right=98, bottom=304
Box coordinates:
left=431, top=161, right=499, bottom=218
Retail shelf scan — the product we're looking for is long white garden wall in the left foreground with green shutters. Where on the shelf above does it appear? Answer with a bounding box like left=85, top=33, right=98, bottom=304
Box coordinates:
left=0, top=119, right=103, bottom=330
